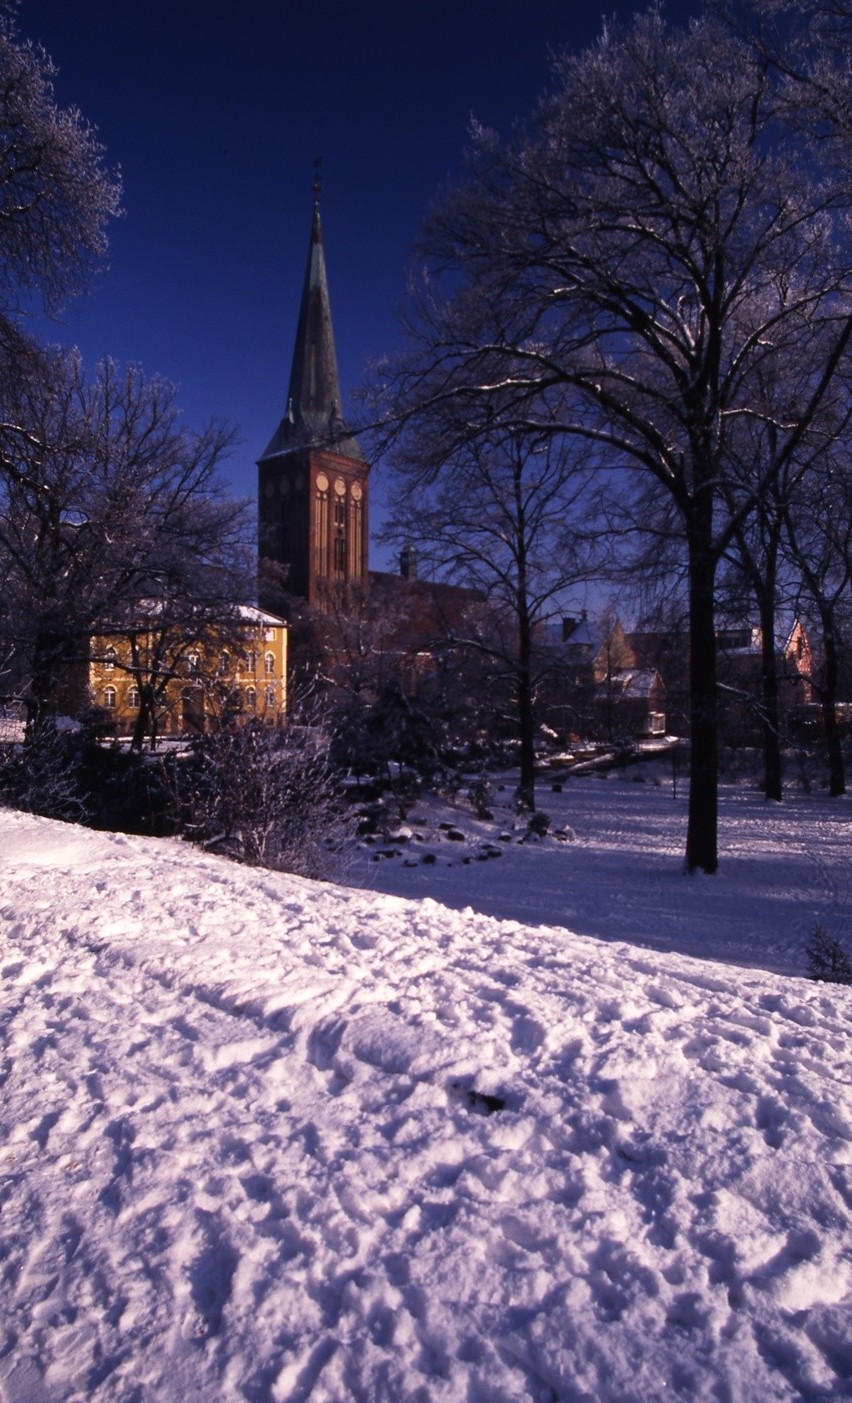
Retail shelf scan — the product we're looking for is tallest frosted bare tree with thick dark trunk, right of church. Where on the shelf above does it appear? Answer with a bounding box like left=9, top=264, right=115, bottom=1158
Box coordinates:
left=376, top=10, right=852, bottom=873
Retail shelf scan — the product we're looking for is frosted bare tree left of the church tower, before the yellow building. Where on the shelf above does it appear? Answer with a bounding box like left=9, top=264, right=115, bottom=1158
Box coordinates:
left=0, top=352, right=247, bottom=734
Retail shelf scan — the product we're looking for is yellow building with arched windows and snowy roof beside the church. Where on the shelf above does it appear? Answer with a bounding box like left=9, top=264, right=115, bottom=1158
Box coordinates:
left=88, top=605, right=288, bottom=744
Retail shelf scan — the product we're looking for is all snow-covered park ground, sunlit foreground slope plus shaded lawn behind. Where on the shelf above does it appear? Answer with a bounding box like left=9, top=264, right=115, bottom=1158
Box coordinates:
left=0, top=780, right=852, bottom=1403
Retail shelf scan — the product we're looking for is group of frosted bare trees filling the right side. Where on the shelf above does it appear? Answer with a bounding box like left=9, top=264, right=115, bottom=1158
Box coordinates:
left=373, top=0, right=852, bottom=873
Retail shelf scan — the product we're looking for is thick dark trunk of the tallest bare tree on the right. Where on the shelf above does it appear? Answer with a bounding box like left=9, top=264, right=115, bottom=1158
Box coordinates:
left=686, top=521, right=719, bottom=873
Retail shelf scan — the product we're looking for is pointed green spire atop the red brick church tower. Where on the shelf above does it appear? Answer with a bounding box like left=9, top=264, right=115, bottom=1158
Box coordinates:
left=261, top=178, right=364, bottom=462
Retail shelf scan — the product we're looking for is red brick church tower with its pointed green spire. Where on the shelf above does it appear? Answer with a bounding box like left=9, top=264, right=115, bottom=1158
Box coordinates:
left=257, top=182, right=369, bottom=609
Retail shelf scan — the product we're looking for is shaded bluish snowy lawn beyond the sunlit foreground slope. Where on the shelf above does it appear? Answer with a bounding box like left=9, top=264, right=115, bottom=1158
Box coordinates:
left=354, top=762, right=852, bottom=974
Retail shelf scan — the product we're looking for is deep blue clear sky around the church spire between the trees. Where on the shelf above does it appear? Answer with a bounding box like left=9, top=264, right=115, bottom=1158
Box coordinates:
left=20, top=0, right=696, bottom=563
